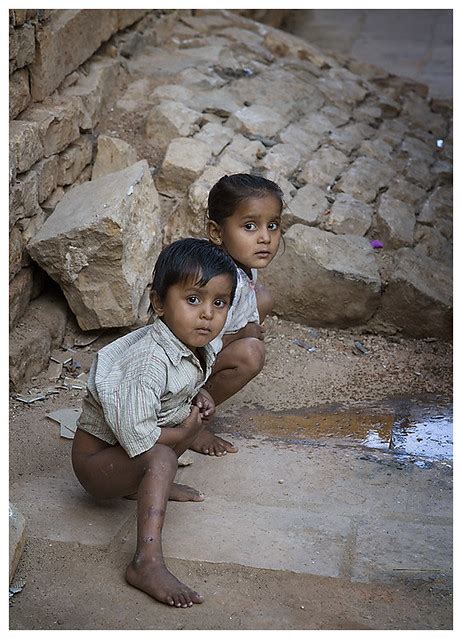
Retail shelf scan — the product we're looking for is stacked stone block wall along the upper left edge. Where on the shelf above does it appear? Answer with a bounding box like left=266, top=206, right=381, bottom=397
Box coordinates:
left=9, top=9, right=168, bottom=336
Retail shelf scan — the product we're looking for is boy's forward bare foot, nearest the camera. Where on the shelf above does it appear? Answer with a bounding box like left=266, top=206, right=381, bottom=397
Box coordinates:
left=125, top=559, right=204, bottom=608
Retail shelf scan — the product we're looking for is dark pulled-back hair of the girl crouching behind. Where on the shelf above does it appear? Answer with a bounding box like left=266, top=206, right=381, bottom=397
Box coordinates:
left=208, top=173, right=283, bottom=224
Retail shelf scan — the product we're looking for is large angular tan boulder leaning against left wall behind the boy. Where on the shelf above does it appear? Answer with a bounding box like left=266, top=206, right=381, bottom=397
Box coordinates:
left=28, top=160, right=161, bottom=330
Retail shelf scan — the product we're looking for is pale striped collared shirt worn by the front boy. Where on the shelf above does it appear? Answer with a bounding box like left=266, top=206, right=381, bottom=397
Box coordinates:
left=78, top=318, right=215, bottom=457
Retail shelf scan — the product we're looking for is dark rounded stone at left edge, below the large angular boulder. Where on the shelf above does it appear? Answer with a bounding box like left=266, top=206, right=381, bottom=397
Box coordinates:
left=9, top=294, right=68, bottom=391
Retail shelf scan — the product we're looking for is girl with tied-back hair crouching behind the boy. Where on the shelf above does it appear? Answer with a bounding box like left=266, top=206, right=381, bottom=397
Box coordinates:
left=191, top=173, right=283, bottom=456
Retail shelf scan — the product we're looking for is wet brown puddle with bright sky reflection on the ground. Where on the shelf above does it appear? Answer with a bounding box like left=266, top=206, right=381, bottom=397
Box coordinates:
left=217, top=396, right=453, bottom=465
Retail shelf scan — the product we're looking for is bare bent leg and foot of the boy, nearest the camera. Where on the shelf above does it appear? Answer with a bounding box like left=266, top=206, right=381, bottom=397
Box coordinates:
left=72, top=430, right=203, bottom=608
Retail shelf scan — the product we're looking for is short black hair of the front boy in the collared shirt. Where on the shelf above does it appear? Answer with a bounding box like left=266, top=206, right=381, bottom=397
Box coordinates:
left=151, top=237, right=237, bottom=303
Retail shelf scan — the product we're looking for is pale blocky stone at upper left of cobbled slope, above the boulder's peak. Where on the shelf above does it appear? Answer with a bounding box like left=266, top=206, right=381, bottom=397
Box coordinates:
left=146, top=100, right=202, bottom=151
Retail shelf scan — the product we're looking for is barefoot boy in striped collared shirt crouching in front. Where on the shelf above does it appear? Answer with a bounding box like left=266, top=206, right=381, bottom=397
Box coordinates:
left=72, top=238, right=236, bottom=608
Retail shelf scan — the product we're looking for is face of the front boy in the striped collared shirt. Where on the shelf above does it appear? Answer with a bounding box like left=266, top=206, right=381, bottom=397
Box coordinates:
left=151, top=274, right=233, bottom=351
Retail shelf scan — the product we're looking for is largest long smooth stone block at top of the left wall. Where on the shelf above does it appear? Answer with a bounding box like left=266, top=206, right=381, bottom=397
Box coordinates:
left=30, top=9, right=118, bottom=101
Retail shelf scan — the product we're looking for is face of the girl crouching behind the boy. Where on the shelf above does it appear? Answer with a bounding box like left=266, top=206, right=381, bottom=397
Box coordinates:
left=209, top=194, right=281, bottom=273
